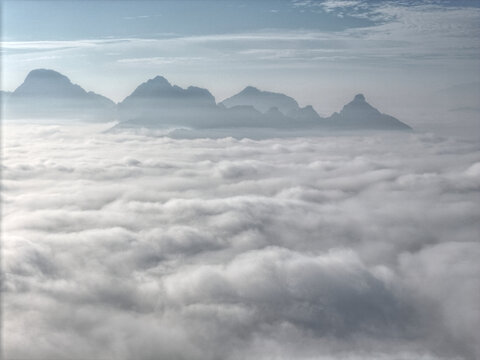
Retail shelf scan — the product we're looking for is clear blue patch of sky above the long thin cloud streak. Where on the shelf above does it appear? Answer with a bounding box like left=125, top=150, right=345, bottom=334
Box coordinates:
left=4, top=0, right=373, bottom=40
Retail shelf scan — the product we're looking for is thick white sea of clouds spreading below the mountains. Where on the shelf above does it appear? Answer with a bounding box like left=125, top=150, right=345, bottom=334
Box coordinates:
left=2, top=125, right=480, bottom=360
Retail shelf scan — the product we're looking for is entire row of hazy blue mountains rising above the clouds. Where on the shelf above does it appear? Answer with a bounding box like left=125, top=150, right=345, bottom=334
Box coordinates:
left=0, top=69, right=411, bottom=133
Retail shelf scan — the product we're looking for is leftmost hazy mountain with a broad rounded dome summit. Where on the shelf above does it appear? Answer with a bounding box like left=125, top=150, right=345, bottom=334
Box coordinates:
left=4, top=69, right=116, bottom=121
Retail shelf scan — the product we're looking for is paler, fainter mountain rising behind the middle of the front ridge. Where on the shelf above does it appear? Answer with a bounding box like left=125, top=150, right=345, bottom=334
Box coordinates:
left=221, top=86, right=299, bottom=115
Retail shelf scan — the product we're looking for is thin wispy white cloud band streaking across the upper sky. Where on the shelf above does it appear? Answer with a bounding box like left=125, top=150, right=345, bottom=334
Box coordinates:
left=1, top=1, right=480, bottom=66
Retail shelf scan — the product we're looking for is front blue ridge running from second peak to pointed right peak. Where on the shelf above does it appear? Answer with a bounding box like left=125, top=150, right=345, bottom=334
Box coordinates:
left=113, top=86, right=410, bottom=137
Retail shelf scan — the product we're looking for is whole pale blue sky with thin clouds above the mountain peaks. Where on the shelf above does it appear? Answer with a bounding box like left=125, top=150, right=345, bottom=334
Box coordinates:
left=2, top=0, right=480, bottom=129
